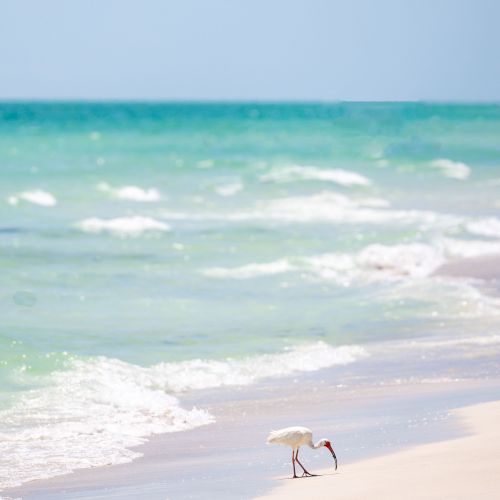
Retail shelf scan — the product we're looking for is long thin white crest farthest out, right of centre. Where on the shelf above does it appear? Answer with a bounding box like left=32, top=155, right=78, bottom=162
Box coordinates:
left=259, top=165, right=372, bottom=186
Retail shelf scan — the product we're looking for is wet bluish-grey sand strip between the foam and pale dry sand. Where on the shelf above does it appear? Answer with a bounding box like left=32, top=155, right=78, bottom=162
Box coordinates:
left=1, top=369, right=500, bottom=500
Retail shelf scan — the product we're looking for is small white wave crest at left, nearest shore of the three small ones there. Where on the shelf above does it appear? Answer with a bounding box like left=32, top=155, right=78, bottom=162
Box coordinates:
left=76, top=215, right=170, bottom=237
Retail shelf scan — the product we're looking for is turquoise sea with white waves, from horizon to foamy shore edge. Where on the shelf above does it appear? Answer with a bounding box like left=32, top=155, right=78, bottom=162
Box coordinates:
left=0, top=102, right=500, bottom=487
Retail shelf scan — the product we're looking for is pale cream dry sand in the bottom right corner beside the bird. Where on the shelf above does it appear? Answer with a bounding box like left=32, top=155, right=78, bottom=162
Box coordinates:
left=261, top=401, right=500, bottom=500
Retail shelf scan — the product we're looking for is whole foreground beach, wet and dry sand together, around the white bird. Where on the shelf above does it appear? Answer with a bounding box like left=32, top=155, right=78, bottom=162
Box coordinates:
left=3, top=362, right=500, bottom=500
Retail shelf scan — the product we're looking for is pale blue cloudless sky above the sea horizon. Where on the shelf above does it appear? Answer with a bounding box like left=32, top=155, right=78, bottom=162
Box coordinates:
left=0, top=0, right=500, bottom=101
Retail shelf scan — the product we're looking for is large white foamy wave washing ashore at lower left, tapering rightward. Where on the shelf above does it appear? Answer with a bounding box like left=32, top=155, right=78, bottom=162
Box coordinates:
left=0, top=342, right=368, bottom=488
